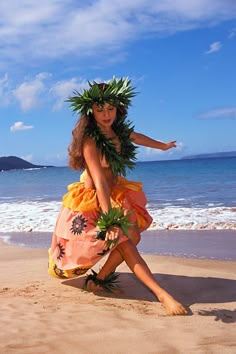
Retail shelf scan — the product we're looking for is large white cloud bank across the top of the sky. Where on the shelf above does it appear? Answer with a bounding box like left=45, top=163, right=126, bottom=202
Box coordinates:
left=0, top=0, right=236, bottom=65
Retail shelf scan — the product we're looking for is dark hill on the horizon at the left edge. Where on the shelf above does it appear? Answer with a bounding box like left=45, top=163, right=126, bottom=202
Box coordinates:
left=0, top=156, right=53, bottom=171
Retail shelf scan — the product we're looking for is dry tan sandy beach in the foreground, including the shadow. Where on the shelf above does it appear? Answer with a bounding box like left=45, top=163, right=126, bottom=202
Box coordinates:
left=0, top=242, right=236, bottom=354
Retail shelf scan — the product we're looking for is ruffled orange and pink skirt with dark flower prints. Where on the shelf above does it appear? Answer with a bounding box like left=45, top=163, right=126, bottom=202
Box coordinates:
left=48, top=177, right=152, bottom=278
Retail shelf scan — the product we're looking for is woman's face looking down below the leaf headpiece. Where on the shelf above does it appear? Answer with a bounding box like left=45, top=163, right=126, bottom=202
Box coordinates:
left=92, top=103, right=117, bottom=129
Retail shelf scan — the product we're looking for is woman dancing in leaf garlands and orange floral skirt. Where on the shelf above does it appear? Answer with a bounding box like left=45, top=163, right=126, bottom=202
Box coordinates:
left=49, top=78, right=187, bottom=315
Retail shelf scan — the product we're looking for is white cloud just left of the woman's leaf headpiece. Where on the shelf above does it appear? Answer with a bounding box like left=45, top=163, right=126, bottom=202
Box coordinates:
left=50, top=78, right=88, bottom=111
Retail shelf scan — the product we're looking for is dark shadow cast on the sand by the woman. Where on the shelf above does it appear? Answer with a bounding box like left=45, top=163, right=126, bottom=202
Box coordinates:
left=62, top=272, right=236, bottom=323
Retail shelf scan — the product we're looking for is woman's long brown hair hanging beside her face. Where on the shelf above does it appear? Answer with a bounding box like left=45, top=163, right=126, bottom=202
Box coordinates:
left=68, top=97, right=127, bottom=170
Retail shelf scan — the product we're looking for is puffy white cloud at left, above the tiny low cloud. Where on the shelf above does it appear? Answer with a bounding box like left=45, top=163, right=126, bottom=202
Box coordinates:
left=13, top=73, right=49, bottom=111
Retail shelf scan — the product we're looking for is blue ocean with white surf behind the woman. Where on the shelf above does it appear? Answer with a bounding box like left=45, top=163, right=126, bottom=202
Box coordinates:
left=0, top=157, right=236, bottom=233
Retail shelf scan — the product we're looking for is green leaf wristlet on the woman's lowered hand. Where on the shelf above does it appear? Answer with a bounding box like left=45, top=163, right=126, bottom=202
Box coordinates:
left=96, top=208, right=133, bottom=248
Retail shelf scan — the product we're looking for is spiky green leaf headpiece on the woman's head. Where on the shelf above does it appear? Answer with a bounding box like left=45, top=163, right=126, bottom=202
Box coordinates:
left=66, top=77, right=136, bottom=115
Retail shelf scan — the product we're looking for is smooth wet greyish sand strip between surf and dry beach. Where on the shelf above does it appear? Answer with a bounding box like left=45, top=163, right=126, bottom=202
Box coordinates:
left=0, top=230, right=236, bottom=261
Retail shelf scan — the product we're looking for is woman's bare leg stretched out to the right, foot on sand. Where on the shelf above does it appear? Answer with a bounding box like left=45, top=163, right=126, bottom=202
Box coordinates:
left=98, top=240, right=187, bottom=315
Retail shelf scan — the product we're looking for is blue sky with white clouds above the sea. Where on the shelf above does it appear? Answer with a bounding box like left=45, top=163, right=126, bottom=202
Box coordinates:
left=0, top=0, right=236, bottom=166
